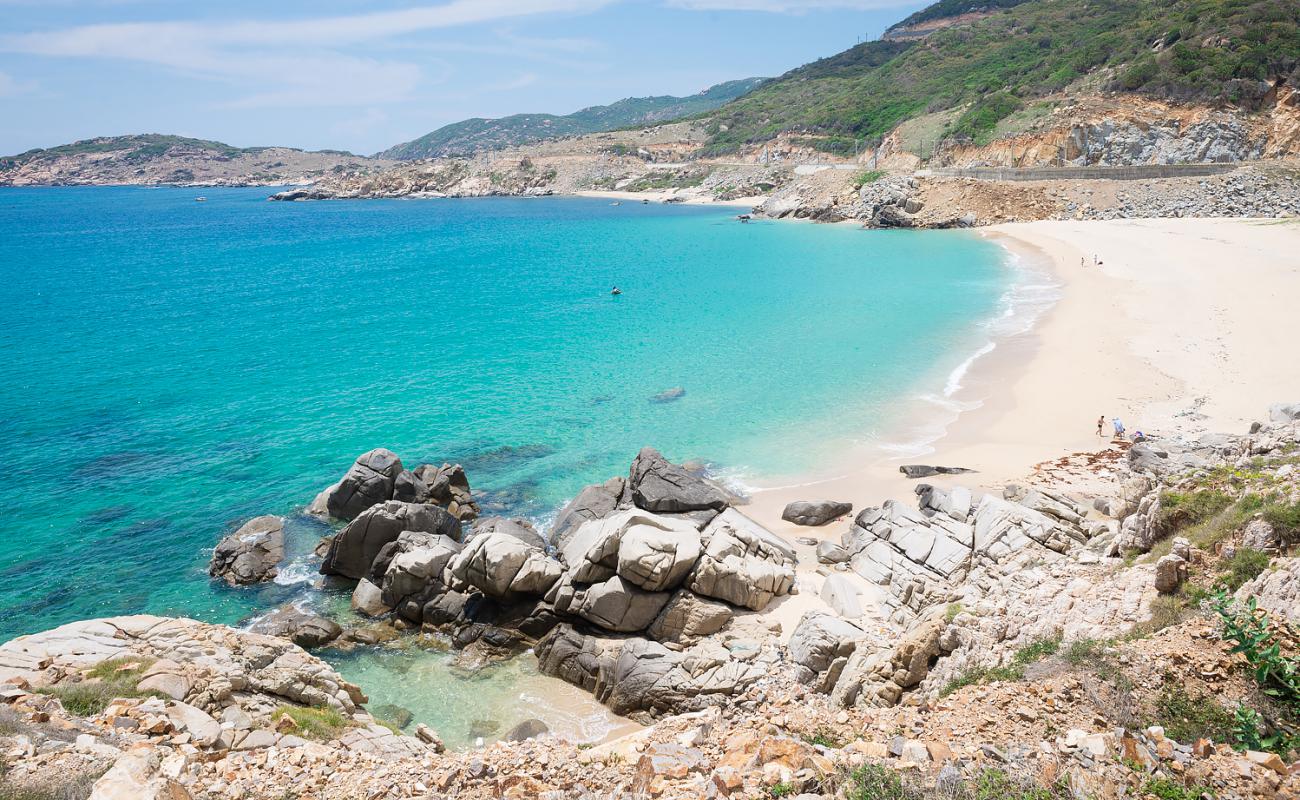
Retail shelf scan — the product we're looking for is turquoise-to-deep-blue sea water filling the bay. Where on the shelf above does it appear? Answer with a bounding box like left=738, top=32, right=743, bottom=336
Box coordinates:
left=0, top=187, right=1014, bottom=739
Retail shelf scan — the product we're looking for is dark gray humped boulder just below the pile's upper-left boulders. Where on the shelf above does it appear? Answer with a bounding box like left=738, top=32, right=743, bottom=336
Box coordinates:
left=321, top=500, right=462, bottom=579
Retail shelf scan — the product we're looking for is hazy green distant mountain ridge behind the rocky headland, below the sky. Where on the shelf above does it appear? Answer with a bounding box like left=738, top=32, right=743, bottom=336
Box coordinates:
left=376, top=78, right=767, bottom=161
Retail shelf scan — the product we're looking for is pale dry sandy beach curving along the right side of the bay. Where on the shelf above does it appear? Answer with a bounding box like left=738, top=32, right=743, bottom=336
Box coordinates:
left=742, top=219, right=1300, bottom=632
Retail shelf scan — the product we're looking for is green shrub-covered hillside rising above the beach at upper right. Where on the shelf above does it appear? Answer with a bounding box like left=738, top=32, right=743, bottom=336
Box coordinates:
left=706, top=0, right=1300, bottom=155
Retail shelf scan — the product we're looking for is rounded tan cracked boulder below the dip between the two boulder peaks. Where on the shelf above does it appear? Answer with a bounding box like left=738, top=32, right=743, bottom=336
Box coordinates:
left=449, top=532, right=564, bottom=598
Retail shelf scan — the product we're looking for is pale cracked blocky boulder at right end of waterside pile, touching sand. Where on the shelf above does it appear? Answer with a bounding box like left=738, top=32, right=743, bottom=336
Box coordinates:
left=686, top=509, right=794, bottom=611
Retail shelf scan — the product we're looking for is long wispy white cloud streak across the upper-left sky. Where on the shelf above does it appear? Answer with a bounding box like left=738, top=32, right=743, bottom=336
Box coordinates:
left=0, top=0, right=612, bottom=108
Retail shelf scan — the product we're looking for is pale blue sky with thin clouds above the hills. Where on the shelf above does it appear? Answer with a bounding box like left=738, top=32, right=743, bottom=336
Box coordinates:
left=0, top=0, right=928, bottom=155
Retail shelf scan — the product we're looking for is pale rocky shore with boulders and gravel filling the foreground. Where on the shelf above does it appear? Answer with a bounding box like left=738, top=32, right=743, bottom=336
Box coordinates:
left=0, top=406, right=1300, bottom=800
